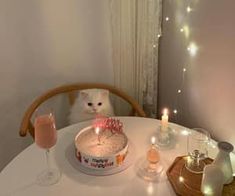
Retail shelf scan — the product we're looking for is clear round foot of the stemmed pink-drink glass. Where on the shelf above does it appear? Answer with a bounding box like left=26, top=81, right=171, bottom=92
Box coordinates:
left=37, top=169, right=61, bottom=186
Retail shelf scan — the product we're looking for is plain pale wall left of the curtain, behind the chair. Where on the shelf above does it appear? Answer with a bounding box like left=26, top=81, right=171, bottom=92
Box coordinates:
left=0, top=0, right=113, bottom=170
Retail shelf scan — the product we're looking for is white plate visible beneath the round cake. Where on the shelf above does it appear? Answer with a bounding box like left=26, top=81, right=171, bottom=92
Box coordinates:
left=77, top=141, right=135, bottom=176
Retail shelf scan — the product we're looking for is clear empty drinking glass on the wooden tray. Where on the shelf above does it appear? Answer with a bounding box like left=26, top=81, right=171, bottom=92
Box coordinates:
left=185, top=128, right=210, bottom=173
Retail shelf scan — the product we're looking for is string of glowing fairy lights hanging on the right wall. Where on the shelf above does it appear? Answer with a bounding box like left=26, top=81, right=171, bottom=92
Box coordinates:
left=157, top=0, right=198, bottom=122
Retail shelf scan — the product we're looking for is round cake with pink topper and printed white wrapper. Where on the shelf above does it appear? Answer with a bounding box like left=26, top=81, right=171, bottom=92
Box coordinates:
left=75, top=119, right=128, bottom=170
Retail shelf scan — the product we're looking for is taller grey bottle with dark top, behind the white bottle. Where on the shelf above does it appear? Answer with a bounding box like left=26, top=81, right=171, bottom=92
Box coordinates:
left=213, top=142, right=233, bottom=184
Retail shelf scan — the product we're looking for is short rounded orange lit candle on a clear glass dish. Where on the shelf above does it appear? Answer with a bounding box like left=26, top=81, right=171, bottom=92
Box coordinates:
left=147, top=137, right=159, bottom=170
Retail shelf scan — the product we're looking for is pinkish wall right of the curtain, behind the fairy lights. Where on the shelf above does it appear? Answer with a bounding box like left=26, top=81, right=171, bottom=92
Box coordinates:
left=159, top=0, right=235, bottom=145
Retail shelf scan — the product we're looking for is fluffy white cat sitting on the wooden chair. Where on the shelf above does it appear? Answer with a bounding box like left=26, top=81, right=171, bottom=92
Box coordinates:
left=69, top=89, right=114, bottom=124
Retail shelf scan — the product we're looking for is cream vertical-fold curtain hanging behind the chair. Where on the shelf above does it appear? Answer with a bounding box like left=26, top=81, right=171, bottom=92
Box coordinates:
left=110, top=0, right=162, bottom=117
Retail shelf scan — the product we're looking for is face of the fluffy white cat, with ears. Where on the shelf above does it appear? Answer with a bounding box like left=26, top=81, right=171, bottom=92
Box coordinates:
left=80, top=89, right=109, bottom=114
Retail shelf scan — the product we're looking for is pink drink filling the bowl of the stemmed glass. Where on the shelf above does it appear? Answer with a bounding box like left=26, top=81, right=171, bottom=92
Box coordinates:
left=34, top=114, right=57, bottom=149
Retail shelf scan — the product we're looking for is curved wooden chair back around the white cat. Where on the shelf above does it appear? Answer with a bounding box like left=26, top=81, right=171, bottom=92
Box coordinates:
left=19, top=83, right=146, bottom=138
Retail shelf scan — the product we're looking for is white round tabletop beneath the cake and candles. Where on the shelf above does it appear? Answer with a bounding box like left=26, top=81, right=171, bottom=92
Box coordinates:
left=0, top=117, right=233, bottom=196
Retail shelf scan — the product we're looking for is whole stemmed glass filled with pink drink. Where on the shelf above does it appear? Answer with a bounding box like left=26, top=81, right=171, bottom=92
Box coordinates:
left=34, top=110, right=61, bottom=186
